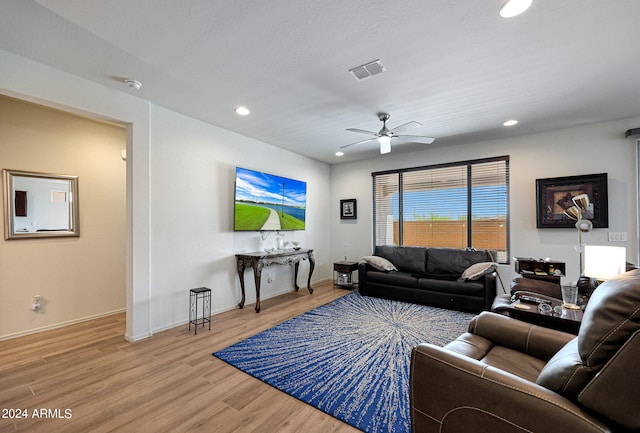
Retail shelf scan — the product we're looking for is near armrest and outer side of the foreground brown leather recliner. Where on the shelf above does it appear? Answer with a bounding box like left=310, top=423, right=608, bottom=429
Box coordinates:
left=410, top=344, right=611, bottom=433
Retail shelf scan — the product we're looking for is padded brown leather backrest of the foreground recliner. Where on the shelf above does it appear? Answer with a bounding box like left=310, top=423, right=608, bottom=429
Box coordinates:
left=537, top=270, right=640, bottom=399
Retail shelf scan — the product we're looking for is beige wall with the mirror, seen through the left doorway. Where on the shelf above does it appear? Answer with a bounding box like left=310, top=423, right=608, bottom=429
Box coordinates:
left=0, top=96, right=126, bottom=339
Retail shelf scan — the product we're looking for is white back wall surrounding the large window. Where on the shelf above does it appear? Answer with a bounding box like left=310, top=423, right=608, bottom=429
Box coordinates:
left=331, top=118, right=640, bottom=285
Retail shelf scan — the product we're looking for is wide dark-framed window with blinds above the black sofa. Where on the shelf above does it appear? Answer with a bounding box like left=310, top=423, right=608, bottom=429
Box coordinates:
left=372, top=156, right=509, bottom=263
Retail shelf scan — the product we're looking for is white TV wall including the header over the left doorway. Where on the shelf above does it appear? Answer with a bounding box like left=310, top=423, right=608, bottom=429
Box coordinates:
left=0, top=50, right=332, bottom=341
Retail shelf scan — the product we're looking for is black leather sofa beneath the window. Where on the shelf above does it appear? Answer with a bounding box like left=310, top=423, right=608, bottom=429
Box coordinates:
left=358, top=245, right=497, bottom=312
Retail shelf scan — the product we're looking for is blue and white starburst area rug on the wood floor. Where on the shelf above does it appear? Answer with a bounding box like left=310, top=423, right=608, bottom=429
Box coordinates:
left=213, top=292, right=474, bottom=433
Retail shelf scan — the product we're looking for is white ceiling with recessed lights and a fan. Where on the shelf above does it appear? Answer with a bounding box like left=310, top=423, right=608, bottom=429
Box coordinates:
left=0, top=0, right=640, bottom=163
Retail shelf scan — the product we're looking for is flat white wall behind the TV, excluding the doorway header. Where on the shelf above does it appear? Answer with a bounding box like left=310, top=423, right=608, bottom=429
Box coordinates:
left=151, top=106, right=332, bottom=330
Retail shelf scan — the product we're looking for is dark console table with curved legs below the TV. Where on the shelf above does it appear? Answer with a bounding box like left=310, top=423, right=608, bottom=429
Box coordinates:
left=236, top=249, right=316, bottom=313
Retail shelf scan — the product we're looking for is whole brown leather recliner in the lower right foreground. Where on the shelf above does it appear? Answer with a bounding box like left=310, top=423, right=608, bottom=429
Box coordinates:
left=410, top=270, right=640, bottom=433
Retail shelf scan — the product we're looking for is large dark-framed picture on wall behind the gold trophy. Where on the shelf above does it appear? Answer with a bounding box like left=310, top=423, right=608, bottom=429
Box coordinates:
left=536, top=173, right=609, bottom=228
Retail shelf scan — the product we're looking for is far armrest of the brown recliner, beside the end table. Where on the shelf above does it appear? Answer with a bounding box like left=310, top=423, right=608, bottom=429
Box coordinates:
left=469, top=311, right=576, bottom=361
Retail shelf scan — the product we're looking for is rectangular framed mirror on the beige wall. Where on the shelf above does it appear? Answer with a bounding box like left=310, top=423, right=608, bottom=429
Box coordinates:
left=2, top=169, right=80, bottom=240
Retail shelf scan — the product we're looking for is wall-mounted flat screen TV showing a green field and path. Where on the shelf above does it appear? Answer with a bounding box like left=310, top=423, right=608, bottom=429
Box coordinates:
left=233, top=167, right=307, bottom=231
